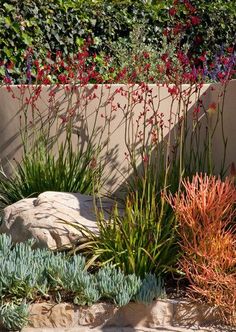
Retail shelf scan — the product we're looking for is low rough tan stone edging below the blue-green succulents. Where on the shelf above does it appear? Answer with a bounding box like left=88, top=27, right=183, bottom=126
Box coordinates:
left=22, top=299, right=231, bottom=332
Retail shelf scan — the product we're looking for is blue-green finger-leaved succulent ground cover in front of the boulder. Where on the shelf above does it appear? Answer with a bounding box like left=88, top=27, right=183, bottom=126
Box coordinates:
left=0, top=234, right=165, bottom=330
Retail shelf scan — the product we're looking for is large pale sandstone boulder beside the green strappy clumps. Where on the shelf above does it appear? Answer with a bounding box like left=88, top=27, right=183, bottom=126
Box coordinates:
left=0, top=192, right=114, bottom=250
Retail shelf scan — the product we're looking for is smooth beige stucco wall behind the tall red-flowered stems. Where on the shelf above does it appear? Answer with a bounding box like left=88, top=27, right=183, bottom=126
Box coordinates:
left=0, top=81, right=236, bottom=191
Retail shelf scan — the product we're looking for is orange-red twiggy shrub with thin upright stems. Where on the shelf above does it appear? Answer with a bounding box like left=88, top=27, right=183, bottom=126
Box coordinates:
left=168, top=174, right=236, bottom=324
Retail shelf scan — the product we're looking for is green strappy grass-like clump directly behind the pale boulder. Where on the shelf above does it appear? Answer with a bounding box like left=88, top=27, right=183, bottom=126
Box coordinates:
left=0, top=137, right=101, bottom=208
